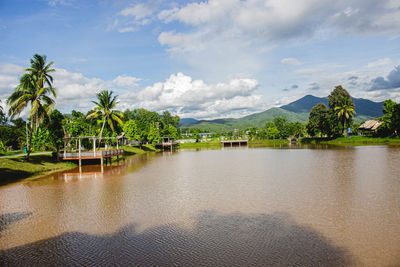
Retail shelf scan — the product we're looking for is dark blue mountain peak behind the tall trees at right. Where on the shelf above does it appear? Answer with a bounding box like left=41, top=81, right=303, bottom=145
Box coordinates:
left=281, top=95, right=383, bottom=118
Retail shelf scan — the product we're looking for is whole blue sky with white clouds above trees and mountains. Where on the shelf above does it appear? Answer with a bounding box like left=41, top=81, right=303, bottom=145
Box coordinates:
left=0, top=0, right=400, bottom=119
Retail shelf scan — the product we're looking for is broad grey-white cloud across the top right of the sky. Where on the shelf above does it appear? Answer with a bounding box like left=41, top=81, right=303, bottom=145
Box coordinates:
left=158, top=0, right=400, bottom=51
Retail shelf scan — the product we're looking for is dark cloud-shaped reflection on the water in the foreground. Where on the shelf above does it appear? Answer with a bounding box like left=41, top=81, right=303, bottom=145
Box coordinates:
left=1, top=211, right=350, bottom=266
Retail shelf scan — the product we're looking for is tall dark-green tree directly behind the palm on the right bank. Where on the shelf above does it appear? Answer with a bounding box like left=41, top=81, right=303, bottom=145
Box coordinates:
left=328, top=85, right=354, bottom=136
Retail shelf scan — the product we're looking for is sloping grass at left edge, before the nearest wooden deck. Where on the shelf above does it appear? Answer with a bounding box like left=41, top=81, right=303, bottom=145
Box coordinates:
left=0, top=155, right=76, bottom=184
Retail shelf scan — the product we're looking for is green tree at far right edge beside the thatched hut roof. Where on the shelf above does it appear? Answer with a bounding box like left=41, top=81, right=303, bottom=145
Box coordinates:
left=379, top=99, right=400, bottom=136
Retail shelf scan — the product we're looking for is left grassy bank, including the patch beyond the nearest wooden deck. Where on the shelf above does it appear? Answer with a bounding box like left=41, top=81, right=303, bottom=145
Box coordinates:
left=0, top=145, right=157, bottom=185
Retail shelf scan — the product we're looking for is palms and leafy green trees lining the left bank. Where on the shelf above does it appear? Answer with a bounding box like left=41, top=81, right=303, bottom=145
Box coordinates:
left=0, top=54, right=180, bottom=159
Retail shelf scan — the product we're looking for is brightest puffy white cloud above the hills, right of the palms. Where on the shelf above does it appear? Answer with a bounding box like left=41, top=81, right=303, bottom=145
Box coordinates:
left=126, top=73, right=266, bottom=119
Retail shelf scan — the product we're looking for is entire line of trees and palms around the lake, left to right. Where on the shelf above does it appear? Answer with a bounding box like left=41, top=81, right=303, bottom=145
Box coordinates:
left=0, top=54, right=400, bottom=158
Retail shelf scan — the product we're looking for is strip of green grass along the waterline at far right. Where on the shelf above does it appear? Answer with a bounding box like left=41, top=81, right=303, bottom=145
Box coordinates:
left=300, top=136, right=400, bottom=146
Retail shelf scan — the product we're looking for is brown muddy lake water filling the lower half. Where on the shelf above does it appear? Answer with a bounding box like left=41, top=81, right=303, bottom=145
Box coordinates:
left=0, top=146, right=400, bottom=266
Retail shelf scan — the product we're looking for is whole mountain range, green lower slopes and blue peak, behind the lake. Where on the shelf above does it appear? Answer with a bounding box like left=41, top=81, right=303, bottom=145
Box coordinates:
left=180, top=95, right=383, bottom=131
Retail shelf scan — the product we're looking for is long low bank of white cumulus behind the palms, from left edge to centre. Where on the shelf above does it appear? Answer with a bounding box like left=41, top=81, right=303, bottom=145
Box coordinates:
left=0, top=64, right=266, bottom=119
